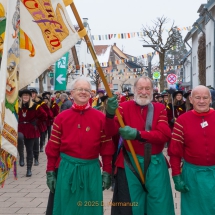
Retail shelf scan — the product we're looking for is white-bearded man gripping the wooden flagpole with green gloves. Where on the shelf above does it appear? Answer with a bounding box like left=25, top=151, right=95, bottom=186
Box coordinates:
left=106, top=77, right=175, bottom=215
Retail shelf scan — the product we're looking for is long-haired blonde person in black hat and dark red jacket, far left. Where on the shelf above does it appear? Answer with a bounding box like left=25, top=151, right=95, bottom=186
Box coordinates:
left=17, top=89, right=47, bottom=177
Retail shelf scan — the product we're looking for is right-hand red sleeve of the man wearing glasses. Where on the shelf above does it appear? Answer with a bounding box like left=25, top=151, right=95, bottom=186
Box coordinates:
left=100, top=133, right=115, bottom=174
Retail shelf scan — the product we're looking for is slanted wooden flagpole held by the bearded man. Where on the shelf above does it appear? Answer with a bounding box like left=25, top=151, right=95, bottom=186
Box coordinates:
left=70, top=1, right=145, bottom=184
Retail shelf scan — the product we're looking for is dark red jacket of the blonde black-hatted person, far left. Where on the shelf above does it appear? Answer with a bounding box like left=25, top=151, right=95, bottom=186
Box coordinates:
left=18, top=103, right=47, bottom=139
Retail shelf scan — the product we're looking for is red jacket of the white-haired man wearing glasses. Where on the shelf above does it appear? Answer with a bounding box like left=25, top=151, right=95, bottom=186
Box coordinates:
left=46, top=107, right=114, bottom=173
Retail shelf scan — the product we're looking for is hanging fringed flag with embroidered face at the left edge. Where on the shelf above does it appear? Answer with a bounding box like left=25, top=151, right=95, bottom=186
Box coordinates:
left=0, top=0, right=20, bottom=186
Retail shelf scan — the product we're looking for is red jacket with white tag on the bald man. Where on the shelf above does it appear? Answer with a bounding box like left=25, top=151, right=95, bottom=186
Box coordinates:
left=168, top=109, right=215, bottom=176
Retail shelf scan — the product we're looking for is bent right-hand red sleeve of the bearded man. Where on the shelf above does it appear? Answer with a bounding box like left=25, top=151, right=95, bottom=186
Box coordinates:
left=140, top=109, right=171, bottom=144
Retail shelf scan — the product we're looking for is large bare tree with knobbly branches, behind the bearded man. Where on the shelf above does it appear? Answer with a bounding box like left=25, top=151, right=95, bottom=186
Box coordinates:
left=142, top=16, right=179, bottom=91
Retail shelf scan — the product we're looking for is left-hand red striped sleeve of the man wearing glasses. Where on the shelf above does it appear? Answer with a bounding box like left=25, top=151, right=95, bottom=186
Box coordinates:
left=45, top=117, right=61, bottom=171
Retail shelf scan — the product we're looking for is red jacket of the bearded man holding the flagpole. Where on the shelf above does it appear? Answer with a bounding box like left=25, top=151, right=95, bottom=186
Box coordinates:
left=105, top=100, right=171, bottom=168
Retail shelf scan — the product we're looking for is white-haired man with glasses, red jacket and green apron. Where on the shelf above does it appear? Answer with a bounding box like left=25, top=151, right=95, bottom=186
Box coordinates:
left=46, top=78, right=114, bottom=215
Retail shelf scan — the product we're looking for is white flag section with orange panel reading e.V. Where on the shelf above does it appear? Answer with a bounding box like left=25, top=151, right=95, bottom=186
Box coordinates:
left=19, top=0, right=80, bottom=89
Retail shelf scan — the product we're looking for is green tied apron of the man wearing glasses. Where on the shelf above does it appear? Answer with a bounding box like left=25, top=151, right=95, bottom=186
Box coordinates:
left=53, top=153, right=103, bottom=215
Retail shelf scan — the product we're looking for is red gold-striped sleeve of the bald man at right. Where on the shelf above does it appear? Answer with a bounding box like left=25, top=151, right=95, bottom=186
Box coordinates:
left=168, top=117, right=184, bottom=176
